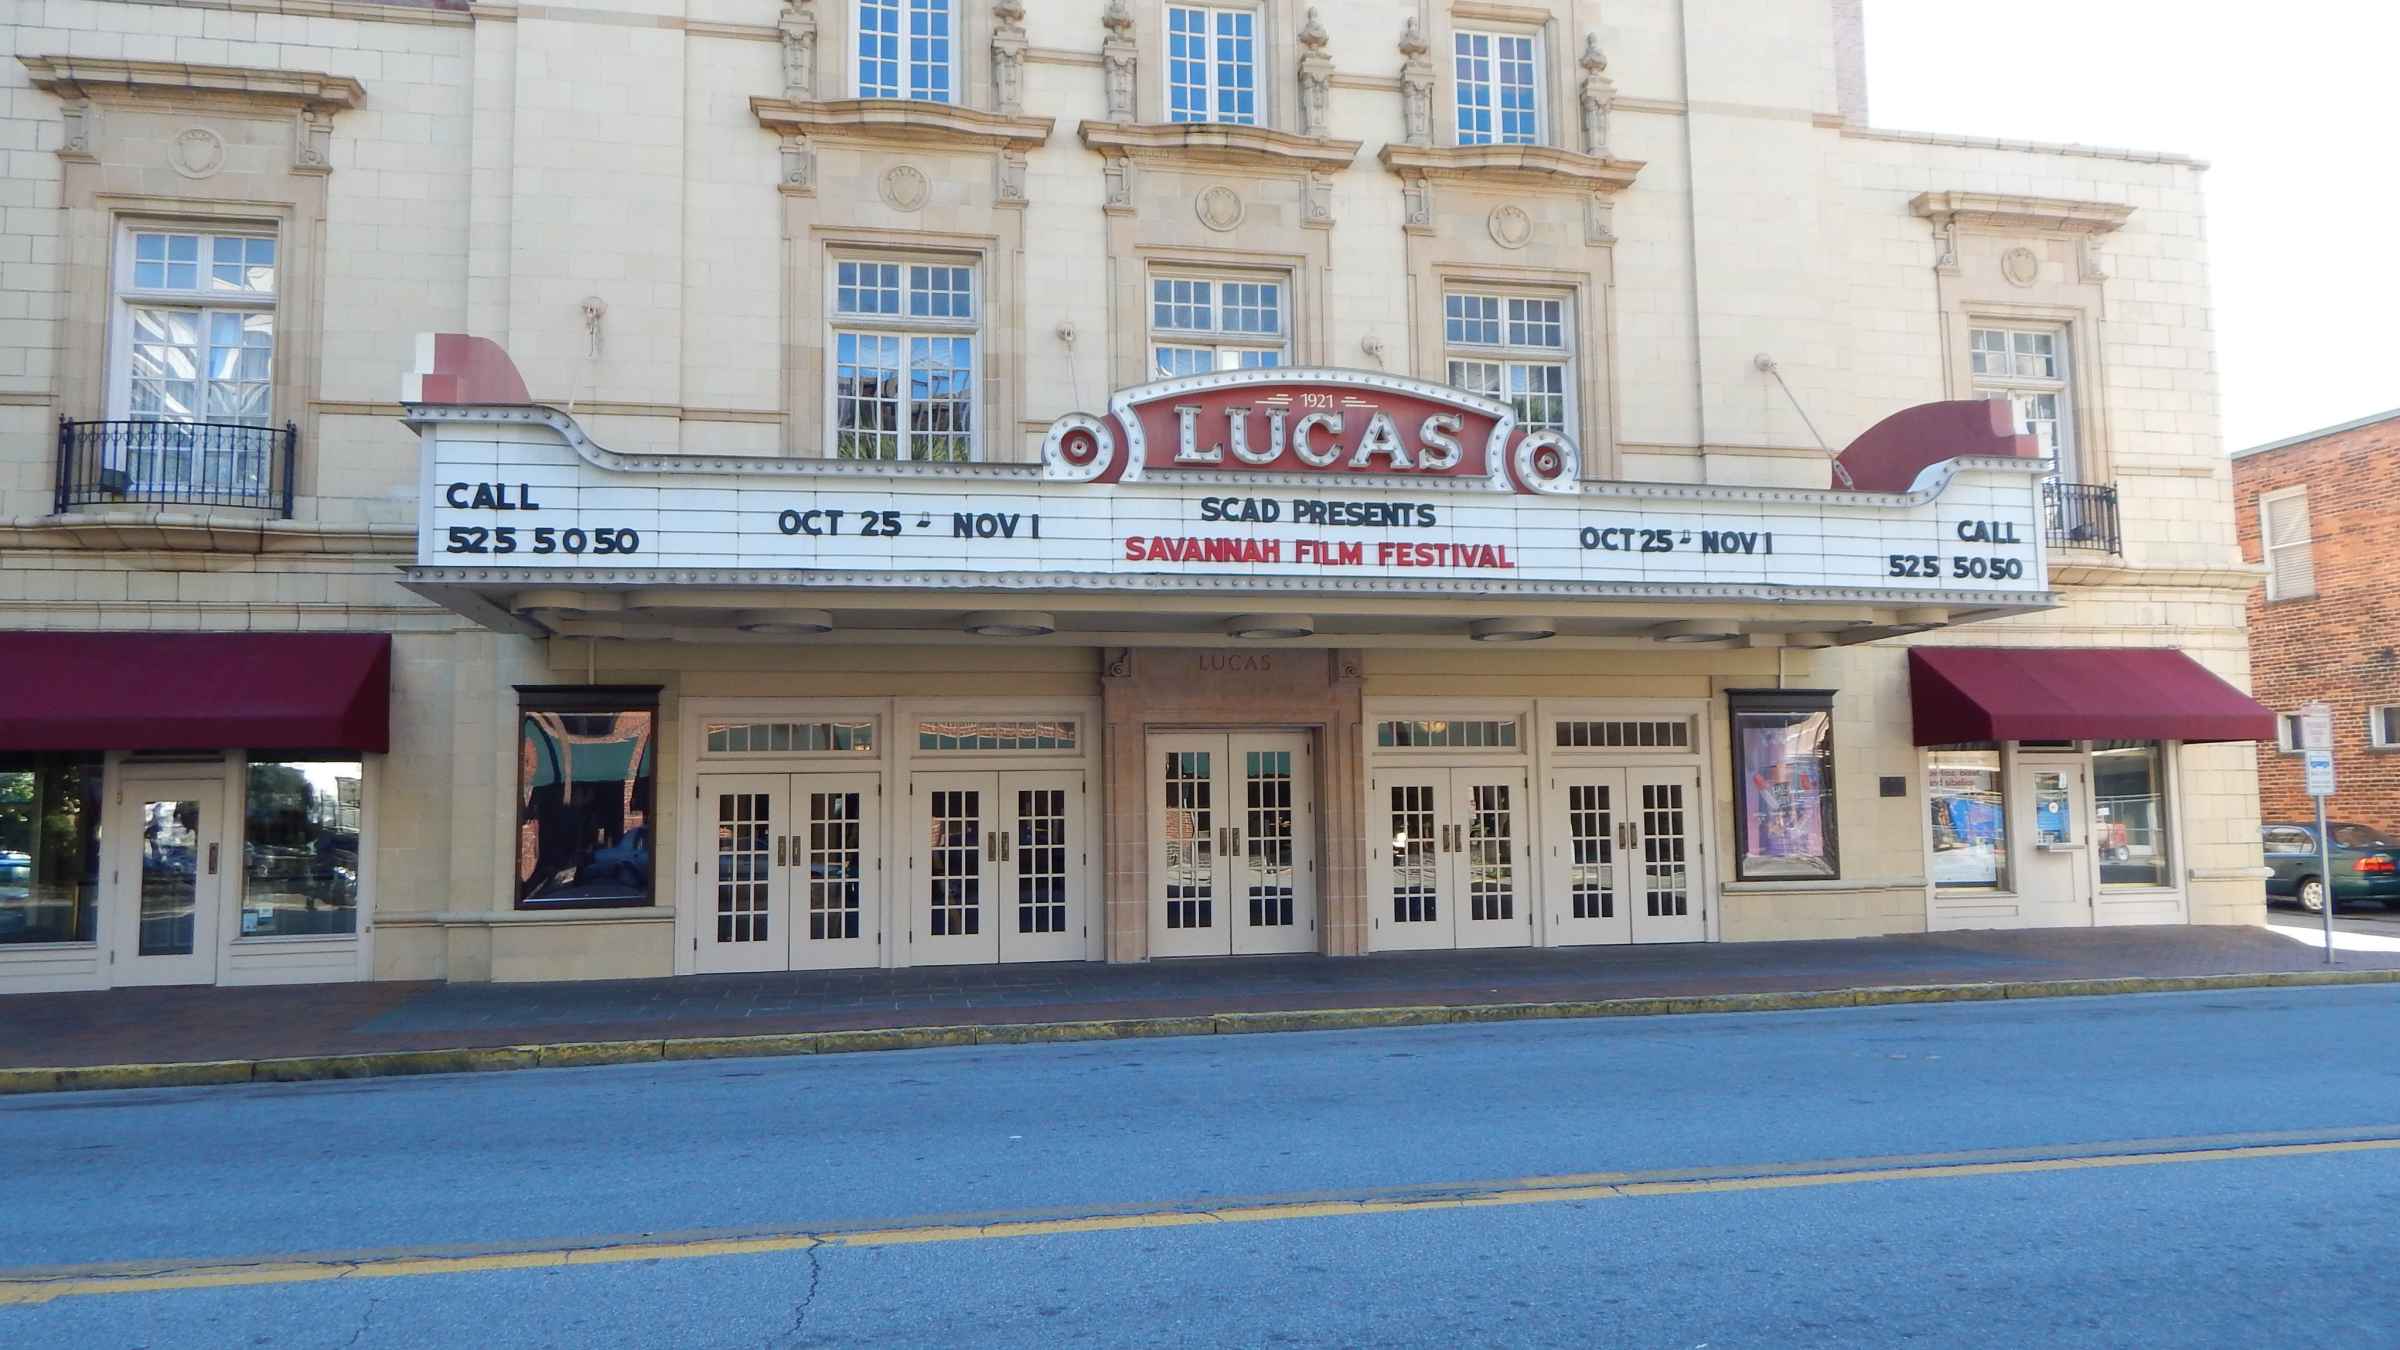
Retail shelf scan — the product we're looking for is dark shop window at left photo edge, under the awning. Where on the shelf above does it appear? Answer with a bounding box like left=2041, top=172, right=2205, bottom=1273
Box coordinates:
left=0, top=752, right=103, bottom=944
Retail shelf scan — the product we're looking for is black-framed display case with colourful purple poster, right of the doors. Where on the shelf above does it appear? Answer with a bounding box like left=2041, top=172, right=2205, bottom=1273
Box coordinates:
left=1728, top=689, right=1841, bottom=882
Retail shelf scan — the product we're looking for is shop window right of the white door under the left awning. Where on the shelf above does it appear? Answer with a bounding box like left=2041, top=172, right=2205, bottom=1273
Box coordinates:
left=242, top=759, right=365, bottom=937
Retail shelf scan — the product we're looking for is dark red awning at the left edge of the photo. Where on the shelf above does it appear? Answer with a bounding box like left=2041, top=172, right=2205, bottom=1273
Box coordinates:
left=0, top=632, right=391, bottom=752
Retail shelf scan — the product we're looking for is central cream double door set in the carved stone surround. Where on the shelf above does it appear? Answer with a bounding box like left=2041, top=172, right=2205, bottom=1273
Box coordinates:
left=1150, top=733, right=1318, bottom=956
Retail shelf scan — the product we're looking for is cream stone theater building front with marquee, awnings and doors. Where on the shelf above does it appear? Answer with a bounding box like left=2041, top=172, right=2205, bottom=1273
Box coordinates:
left=0, top=0, right=2273, bottom=992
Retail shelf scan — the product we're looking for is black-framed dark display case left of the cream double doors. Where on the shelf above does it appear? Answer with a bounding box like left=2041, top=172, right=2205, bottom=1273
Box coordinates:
left=516, top=687, right=658, bottom=910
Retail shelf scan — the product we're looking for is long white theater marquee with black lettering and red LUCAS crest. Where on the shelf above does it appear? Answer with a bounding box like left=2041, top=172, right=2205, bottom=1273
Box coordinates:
left=410, top=370, right=2050, bottom=608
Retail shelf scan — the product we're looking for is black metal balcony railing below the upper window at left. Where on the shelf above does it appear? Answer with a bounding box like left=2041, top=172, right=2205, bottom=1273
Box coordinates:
left=58, top=418, right=300, bottom=516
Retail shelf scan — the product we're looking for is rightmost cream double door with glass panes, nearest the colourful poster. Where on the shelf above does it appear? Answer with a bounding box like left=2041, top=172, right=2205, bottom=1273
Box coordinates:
left=1543, top=766, right=1709, bottom=946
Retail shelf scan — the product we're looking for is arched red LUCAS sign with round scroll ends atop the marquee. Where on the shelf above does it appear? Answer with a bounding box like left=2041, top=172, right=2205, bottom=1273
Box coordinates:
left=1042, top=370, right=1579, bottom=492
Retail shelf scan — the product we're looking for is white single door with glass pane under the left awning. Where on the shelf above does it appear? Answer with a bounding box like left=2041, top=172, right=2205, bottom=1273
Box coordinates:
left=101, top=776, right=230, bottom=985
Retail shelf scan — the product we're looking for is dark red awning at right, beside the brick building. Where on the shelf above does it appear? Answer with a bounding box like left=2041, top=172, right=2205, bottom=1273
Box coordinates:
left=1908, top=646, right=2275, bottom=745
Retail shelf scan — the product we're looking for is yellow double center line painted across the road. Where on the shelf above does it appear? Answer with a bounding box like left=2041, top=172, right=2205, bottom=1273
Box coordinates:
left=0, top=1127, right=2400, bottom=1304
